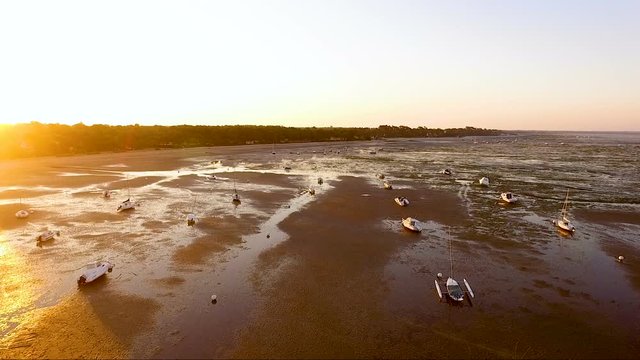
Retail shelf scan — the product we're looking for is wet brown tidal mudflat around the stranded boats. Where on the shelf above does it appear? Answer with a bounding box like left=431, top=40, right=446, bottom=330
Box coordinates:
left=0, top=133, right=640, bottom=358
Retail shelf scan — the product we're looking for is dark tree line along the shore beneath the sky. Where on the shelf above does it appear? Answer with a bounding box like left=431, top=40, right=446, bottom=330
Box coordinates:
left=0, top=122, right=501, bottom=159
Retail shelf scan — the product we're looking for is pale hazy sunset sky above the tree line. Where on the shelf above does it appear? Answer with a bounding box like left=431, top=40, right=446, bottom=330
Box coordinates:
left=0, top=0, right=640, bottom=130
